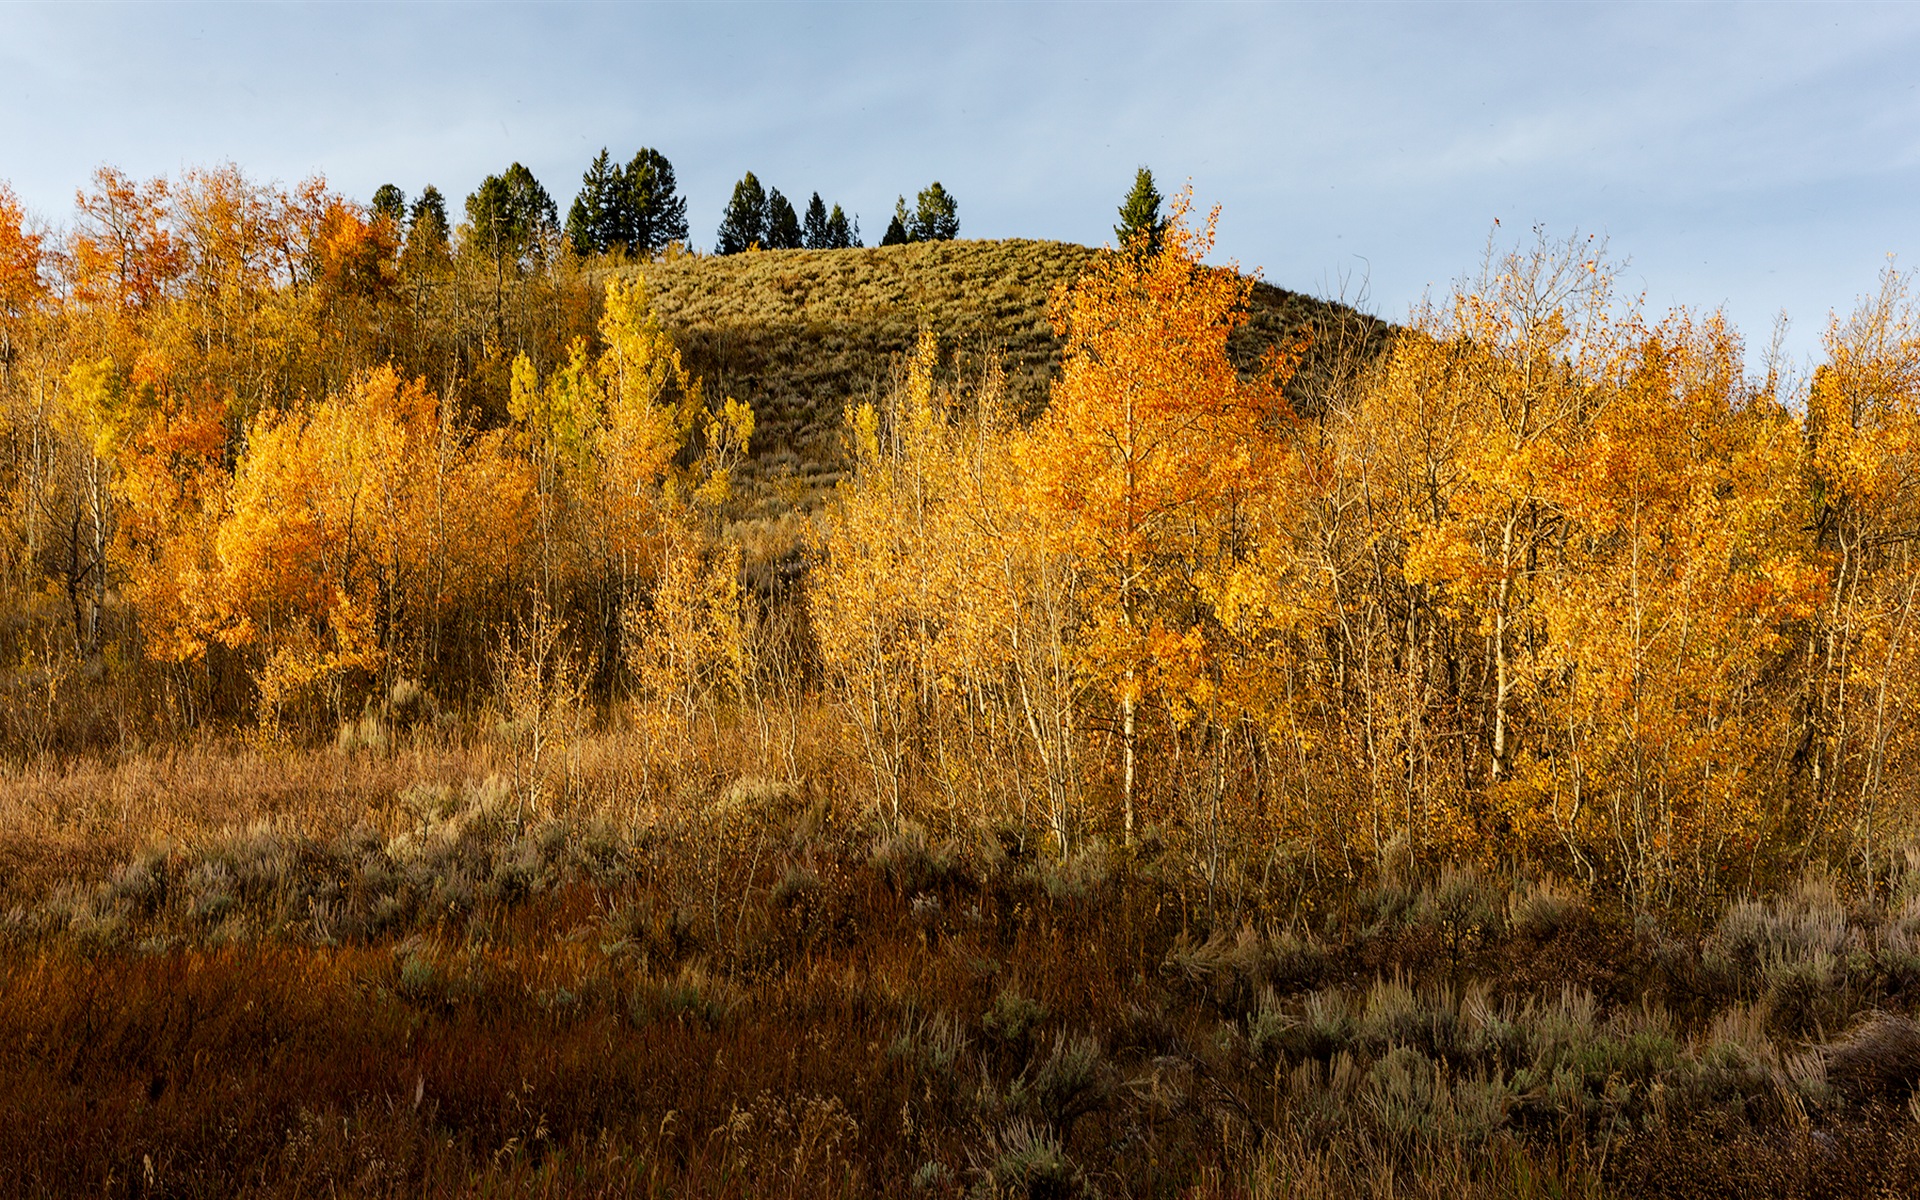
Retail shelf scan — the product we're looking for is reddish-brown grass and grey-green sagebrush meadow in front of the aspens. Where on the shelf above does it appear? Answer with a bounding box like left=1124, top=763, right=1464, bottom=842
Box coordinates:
left=11, top=735, right=1920, bottom=1196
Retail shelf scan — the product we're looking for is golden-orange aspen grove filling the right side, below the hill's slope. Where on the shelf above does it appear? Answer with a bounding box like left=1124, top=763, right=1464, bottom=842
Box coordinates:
left=812, top=203, right=1914, bottom=902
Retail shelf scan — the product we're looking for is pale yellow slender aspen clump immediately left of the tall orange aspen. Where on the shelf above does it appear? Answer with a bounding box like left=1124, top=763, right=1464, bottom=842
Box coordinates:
left=808, top=328, right=1029, bottom=837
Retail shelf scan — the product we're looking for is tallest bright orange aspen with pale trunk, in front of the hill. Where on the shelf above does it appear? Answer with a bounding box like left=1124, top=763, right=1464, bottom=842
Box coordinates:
left=1020, top=194, right=1288, bottom=845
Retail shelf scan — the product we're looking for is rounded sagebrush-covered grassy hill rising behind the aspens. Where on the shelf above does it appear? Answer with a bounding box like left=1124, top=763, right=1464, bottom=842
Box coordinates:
left=622, top=240, right=1390, bottom=515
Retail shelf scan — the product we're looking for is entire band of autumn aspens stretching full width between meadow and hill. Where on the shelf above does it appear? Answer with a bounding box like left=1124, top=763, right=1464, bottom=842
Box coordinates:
left=0, top=156, right=1920, bottom=900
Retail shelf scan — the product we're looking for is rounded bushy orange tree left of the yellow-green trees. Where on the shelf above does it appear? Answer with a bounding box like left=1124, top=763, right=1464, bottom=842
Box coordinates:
left=200, top=367, right=528, bottom=724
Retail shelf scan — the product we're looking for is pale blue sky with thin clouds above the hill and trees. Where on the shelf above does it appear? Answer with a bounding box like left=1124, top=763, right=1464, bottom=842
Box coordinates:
left=0, top=0, right=1920, bottom=372
